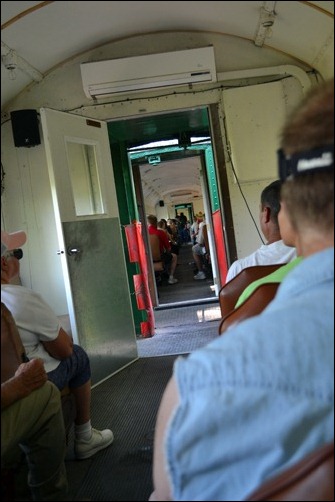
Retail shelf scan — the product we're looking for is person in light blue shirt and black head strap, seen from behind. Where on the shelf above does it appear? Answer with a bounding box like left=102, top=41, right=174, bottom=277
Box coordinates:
left=150, top=80, right=334, bottom=501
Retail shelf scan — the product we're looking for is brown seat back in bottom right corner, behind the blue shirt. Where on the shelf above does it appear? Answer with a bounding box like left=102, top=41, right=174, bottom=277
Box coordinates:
left=246, top=442, right=334, bottom=502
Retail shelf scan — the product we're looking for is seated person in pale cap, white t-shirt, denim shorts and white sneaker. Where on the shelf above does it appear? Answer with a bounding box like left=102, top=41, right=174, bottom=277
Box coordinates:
left=1, top=229, right=114, bottom=460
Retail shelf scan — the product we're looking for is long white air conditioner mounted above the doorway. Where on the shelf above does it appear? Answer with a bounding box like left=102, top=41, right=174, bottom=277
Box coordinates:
left=80, top=47, right=217, bottom=98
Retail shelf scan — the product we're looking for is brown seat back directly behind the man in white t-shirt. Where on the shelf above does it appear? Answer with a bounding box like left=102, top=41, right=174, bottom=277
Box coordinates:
left=219, top=263, right=286, bottom=317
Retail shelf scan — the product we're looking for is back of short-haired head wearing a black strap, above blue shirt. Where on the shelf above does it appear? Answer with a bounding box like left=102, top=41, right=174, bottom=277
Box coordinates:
left=278, top=79, right=334, bottom=235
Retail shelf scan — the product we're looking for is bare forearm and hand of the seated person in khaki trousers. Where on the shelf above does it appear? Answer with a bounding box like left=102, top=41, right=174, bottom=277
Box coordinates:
left=1, top=359, right=48, bottom=410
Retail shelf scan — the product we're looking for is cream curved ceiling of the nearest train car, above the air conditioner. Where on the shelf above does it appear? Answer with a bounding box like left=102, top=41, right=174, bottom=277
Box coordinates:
left=1, top=1, right=334, bottom=106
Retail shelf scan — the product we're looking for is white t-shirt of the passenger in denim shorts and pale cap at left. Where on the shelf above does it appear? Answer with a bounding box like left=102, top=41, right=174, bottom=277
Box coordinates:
left=1, top=284, right=61, bottom=372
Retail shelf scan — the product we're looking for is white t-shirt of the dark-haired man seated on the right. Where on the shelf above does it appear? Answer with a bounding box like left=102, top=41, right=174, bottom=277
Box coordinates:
left=226, top=240, right=297, bottom=282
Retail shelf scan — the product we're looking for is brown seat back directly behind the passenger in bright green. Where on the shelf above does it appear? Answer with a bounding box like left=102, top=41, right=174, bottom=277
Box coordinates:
left=219, top=282, right=280, bottom=335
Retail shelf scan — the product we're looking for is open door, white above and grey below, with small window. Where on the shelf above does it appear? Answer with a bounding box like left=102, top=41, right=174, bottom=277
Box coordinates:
left=40, top=108, right=138, bottom=384
